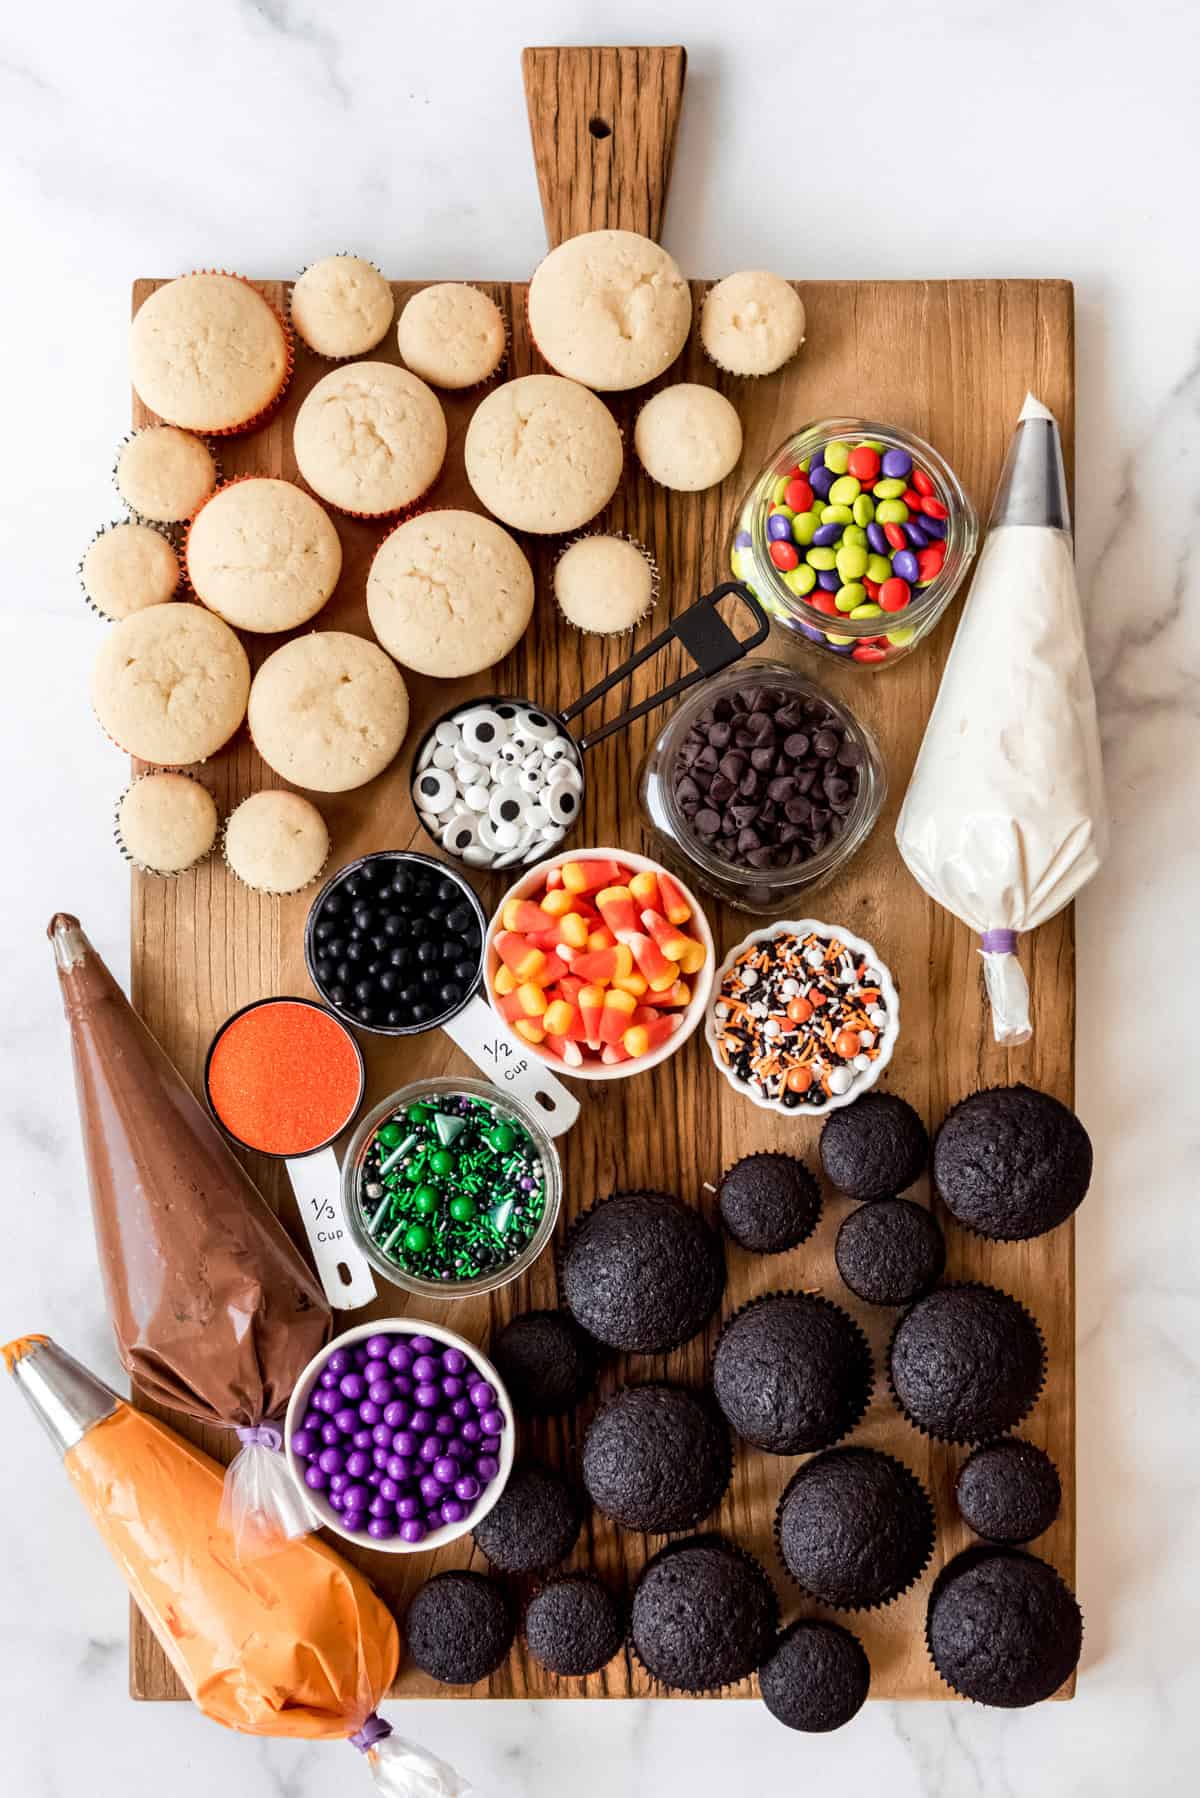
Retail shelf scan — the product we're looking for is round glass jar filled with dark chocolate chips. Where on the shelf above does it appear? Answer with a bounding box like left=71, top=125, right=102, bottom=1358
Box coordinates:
left=639, top=662, right=887, bottom=912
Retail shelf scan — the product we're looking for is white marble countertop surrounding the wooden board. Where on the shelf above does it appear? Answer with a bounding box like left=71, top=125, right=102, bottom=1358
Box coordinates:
left=0, top=0, right=1200, bottom=1798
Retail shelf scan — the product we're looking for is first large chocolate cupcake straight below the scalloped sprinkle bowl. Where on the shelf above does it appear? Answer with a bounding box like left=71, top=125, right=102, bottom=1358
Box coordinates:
left=712, top=1293, right=873, bottom=1455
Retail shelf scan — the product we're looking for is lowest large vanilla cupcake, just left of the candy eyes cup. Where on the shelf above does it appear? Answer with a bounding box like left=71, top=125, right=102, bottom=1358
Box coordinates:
left=250, top=631, right=408, bottom=793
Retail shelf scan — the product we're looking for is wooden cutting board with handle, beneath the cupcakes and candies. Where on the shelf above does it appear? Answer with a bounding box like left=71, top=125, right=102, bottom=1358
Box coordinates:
left=131, top=49, right=1076, bottom=1699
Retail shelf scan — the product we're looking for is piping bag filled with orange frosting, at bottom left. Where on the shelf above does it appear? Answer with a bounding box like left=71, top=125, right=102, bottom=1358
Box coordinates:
left=4, top=1336, right=470, bottom=1798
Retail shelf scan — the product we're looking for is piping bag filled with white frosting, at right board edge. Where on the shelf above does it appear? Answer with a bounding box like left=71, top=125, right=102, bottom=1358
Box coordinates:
left=896, top=394, right=1108, bottom=1045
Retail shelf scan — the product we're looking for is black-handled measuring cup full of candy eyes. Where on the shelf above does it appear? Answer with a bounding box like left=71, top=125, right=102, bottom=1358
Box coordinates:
left=412, top=581, right=770, bottom=868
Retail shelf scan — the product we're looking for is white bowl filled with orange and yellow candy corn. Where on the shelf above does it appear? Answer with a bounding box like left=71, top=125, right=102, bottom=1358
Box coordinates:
left=484, top=849, right=716, bottom=1081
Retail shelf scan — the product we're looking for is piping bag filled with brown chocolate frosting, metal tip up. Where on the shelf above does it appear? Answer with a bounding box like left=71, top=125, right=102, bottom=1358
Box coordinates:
left=49, top=912, right=333, bottom=1557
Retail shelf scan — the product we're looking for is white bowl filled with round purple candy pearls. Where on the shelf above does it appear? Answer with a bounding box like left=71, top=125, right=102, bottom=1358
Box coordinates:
left=284, top=1318, right=516, bottom=1555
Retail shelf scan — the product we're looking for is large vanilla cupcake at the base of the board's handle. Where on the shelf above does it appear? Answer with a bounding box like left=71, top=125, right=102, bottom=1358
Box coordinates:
left=529, top=230, right=691, bottom=392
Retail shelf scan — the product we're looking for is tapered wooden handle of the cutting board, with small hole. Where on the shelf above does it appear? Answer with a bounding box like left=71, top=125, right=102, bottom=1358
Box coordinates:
left=522, top=43, right=687, bottom=250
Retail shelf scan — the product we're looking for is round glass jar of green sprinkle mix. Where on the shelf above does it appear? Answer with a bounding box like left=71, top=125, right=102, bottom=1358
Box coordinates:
left=342, top=1079, right=563, bottom=1298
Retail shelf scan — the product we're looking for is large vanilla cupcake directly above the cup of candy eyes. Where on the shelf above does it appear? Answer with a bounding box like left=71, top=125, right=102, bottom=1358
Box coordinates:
left=367, top=511, right=533, bottom=680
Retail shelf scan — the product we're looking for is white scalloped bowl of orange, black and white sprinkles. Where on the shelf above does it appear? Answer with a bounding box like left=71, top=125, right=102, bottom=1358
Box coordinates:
left=703, top=917, right=900, bottom=1115
